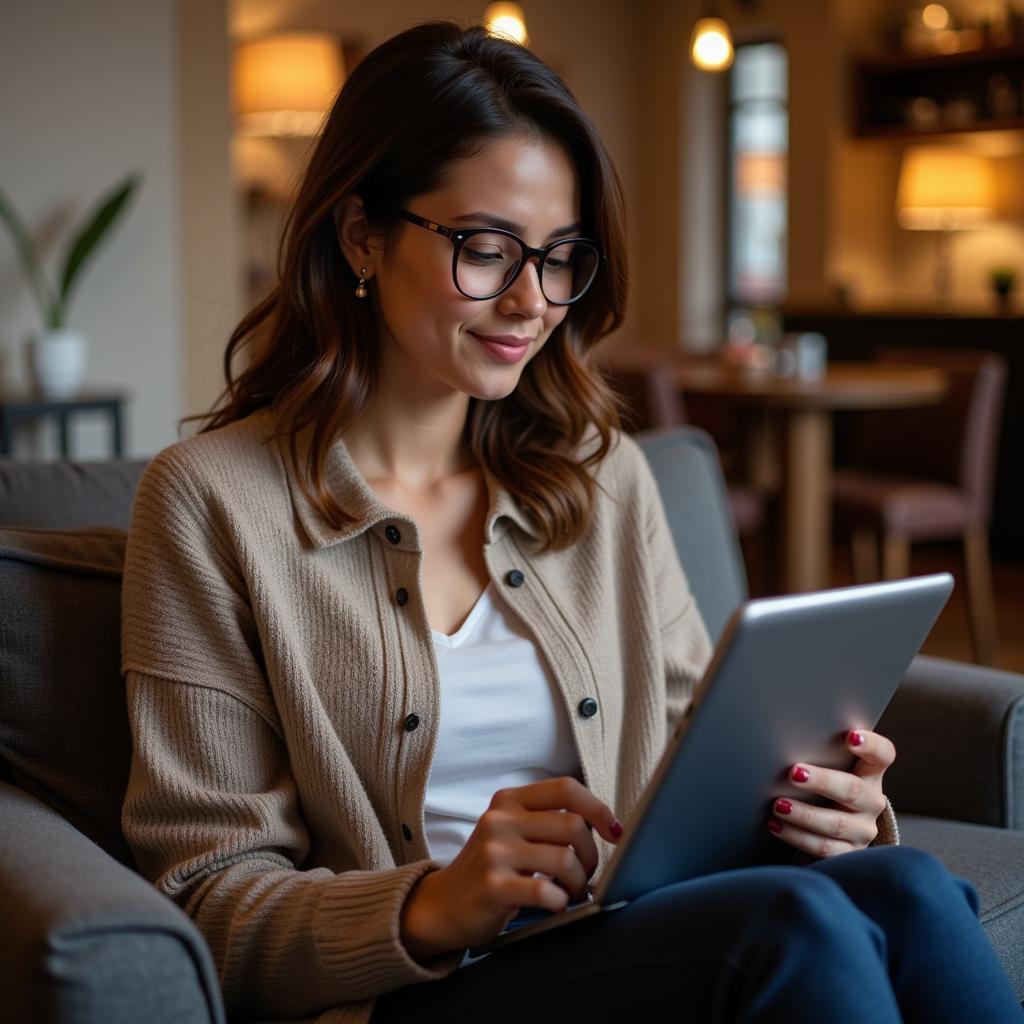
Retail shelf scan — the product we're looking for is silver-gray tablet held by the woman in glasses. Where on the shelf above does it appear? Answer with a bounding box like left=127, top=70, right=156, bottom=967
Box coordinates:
left=470, top=572, right=953, bottom=957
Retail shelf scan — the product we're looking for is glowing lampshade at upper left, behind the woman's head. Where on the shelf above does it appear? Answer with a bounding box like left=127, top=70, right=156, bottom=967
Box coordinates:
left=234, top=32, right=345, bottom=135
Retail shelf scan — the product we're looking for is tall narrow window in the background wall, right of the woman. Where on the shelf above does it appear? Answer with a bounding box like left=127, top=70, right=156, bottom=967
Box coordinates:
left=728, top=43, right=790, bottom=305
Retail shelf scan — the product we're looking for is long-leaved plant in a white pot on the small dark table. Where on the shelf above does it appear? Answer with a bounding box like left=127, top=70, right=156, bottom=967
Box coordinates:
left=0, top=174, right=140, bottom=398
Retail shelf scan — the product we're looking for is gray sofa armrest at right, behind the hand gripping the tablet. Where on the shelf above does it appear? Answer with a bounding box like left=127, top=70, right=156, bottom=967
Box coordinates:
left=878, top=655, right=1024, bottom=829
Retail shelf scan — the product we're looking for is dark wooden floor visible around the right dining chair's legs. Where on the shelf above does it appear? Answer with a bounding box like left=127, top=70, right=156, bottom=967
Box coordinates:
left=790, top=544, right=1024, bottom=673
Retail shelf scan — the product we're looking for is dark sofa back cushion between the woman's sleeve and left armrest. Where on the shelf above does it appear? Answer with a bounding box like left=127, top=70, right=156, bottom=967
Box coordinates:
left=0, top=526, right=132, bottom=864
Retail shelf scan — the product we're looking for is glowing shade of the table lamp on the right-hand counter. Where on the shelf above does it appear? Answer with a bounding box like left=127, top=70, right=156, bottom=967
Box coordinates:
left=896, top=145, right=995, bottom=231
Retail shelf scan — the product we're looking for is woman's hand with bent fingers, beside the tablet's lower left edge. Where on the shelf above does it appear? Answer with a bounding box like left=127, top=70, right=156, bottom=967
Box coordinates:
left=401, top=776, right=622, bottom=961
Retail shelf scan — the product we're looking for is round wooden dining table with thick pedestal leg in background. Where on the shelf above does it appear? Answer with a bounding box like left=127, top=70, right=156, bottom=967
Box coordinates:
left=602, top=350, right=948, bottom=593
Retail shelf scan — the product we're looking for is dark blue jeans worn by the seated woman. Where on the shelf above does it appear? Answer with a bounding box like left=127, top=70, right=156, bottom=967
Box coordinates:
left=372, top=847, right=1024, bottom=1024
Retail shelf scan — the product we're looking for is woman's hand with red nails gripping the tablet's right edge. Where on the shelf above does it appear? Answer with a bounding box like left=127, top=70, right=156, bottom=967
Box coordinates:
left=768, top=729, right=896, bottom=857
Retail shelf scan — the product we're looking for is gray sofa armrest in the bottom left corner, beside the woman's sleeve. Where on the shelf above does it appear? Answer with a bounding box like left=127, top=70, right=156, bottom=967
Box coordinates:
left=0, top=782, right=224, bottom=1024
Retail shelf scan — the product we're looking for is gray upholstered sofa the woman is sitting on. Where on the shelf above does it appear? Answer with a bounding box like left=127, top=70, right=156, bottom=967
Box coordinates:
left=0, top=428, right=1024, bottom=1024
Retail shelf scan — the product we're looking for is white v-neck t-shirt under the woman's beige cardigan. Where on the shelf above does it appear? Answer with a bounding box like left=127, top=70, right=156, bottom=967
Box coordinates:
left=424, top=584, right=583, bottom=865
